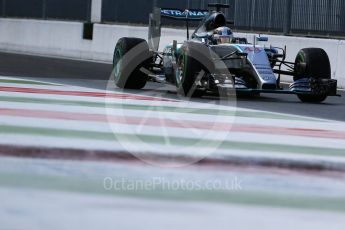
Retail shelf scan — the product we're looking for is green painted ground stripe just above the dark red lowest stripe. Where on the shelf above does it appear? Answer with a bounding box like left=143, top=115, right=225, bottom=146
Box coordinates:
left=0, top=125, right=345, bottom=157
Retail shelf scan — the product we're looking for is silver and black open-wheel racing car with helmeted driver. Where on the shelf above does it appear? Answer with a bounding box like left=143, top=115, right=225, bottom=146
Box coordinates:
left=113, top=4, right=338, bottom=103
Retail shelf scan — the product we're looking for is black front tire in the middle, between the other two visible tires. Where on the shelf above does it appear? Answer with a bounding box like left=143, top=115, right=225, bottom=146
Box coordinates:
left=175, top=47, right=207, bottom=98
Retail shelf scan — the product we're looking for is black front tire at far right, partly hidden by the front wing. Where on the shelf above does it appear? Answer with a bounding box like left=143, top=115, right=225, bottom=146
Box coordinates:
left=294, top=48, right=331, bottom=103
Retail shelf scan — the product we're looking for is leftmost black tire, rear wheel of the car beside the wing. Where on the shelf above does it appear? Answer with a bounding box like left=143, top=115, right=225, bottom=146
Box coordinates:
left=113, top=37, right=152, bottom=89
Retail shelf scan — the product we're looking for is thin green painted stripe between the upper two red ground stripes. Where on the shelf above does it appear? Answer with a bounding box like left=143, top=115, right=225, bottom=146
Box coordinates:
left=0, top=96, right=320, bottom=121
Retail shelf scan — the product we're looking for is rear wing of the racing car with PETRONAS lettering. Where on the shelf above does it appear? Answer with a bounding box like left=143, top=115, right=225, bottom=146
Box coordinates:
left=148, top=7, right=210, bottom=51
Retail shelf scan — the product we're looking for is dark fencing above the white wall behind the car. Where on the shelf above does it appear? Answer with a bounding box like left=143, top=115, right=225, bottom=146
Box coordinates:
left=0, top=0, right=345, bottom=36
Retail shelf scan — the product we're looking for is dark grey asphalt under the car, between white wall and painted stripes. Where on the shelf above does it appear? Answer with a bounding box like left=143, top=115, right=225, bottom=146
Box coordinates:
left=0, top=53, right=345, bottom=121
